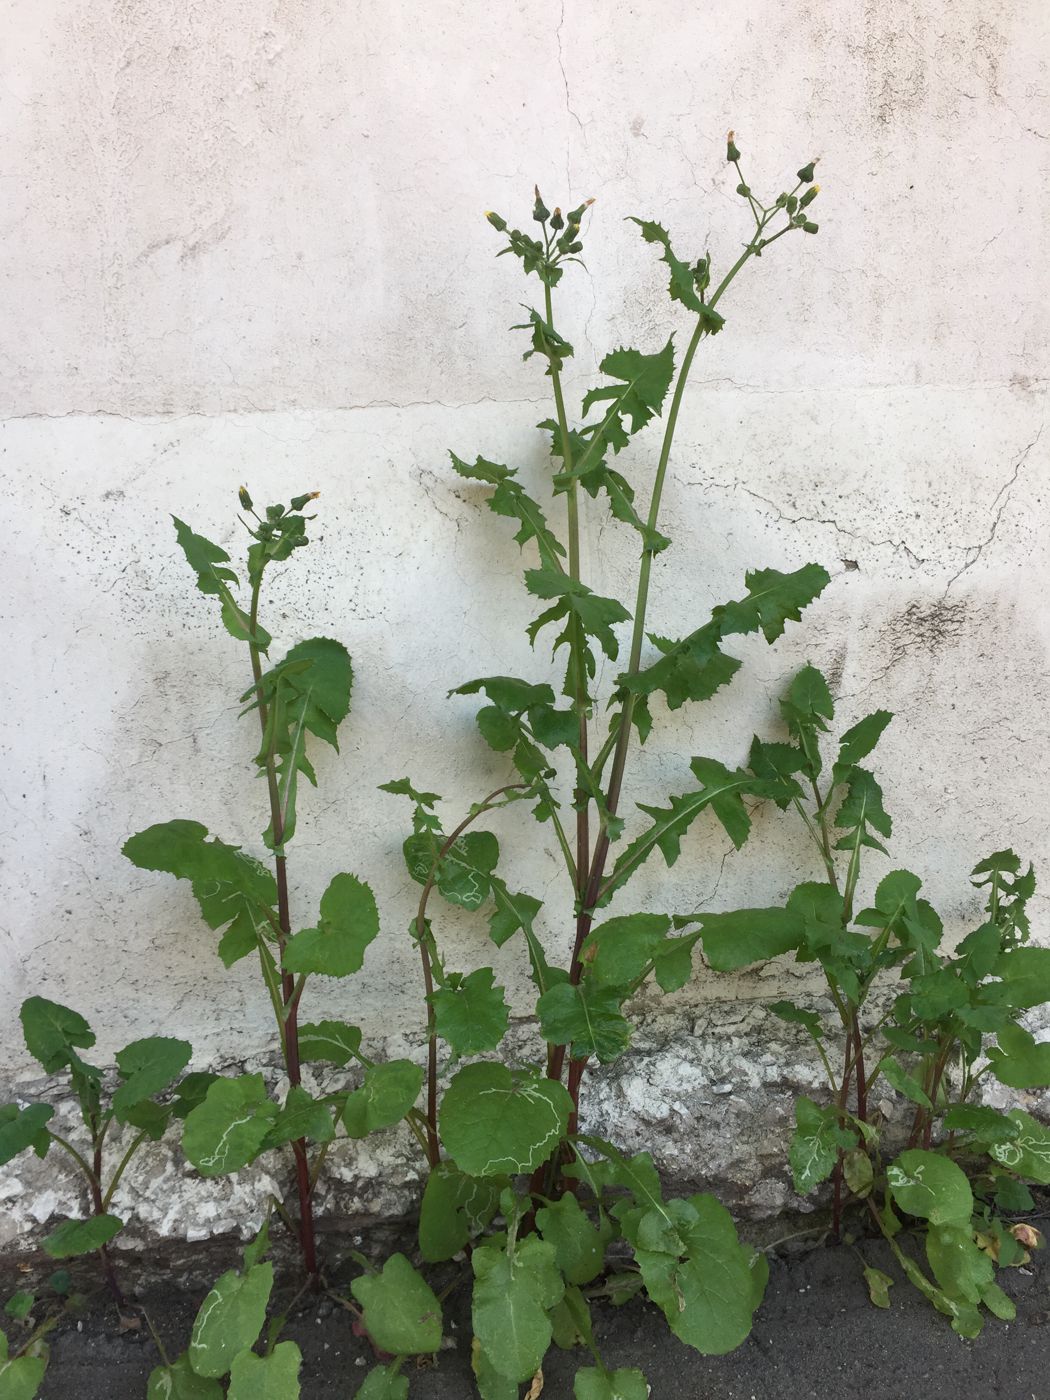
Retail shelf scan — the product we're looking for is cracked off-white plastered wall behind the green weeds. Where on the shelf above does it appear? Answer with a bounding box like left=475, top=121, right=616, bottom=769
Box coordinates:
left=0, top=0, right=1050, bottom=1248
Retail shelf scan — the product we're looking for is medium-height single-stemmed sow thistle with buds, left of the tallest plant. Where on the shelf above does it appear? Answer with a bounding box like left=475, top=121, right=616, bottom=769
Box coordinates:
left=123, top=487, right=423, bottom=1281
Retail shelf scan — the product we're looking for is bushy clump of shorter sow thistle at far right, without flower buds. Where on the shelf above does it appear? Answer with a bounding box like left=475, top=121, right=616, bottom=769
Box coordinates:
left=700, top=665, right=1050, bottom=1337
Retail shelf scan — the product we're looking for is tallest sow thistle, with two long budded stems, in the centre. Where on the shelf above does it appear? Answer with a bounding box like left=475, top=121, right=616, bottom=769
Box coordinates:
left=378, top=137, right=829, bottom=1400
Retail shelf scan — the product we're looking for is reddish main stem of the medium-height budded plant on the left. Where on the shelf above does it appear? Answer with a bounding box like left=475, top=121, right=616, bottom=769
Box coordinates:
left=248, top=573, right=318, bottom=1278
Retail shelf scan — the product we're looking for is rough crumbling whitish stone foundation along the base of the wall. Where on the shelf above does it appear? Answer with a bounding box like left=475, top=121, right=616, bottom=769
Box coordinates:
left=0, top=1001, right=1050, bottom=1250
